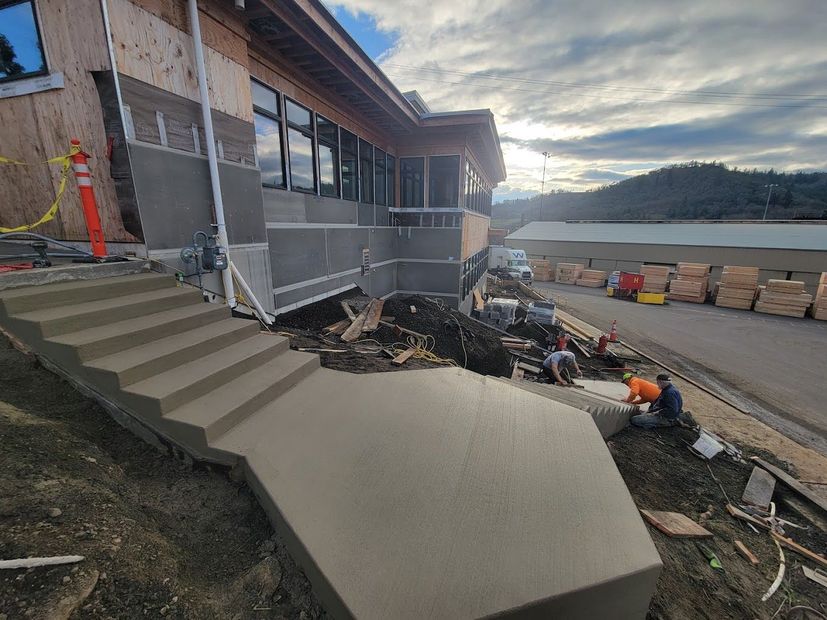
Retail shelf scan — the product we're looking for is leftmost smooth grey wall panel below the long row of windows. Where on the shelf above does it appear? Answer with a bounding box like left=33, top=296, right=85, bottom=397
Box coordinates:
left=267, top=228, right=328, bottom=288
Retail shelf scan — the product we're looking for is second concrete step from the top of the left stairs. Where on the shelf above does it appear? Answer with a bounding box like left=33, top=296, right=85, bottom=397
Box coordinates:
left=9, top=287, right=203, bottom=339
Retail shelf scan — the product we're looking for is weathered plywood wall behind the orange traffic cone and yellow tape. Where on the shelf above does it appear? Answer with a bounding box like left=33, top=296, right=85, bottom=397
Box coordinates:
left=0, top=0, right=139, bottom=242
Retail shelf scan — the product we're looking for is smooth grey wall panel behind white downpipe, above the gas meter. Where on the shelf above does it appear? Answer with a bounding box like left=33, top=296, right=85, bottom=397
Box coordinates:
left=129, top=142, right=267, bottom=249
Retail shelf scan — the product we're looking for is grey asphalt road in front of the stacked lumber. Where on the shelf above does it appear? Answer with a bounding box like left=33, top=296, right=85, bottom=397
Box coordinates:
left=535, top=282, right=827, bottom=455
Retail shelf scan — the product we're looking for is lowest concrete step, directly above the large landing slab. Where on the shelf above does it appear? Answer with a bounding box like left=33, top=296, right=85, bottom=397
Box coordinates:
left=164, top=348, right=319, bottom=446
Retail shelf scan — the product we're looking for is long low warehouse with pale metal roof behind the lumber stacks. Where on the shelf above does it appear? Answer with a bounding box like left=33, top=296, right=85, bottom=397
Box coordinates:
left=506, top=221, right=827, bottom=293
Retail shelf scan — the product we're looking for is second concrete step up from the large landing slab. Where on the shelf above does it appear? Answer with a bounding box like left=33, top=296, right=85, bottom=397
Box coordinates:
left=121, top=335, right=289, bottom=416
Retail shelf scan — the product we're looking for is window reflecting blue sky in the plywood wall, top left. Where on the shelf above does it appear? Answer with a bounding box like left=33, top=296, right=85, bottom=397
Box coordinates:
left=0, top=0, right=47, bottom=82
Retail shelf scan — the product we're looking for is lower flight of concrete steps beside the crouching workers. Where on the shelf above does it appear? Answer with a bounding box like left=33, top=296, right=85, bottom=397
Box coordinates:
left=497, top=379, right=637, bottom=439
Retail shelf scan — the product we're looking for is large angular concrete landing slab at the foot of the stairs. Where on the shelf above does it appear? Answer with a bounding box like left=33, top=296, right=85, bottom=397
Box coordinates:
left=217, top=369, right=661, bottom=620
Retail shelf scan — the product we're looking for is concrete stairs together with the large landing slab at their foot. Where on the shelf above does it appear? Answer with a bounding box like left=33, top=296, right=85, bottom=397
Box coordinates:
left=0, top=273, right=661, bottom=620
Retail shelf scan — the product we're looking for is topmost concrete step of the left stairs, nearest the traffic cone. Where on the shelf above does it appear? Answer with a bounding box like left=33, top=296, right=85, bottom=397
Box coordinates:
left=0, top=273, right=175, bottom=316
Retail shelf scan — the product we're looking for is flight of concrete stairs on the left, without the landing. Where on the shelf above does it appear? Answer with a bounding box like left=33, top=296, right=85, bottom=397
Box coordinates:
left=0, top=273, right=319, bottom=464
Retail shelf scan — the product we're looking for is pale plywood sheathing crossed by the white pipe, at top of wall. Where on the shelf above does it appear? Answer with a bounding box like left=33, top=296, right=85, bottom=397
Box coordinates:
left=109, top=0, right=253, bottom=122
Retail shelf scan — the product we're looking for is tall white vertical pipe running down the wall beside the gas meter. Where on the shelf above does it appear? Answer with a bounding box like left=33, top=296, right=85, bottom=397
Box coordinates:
left=187, top=0, right=237, bottom=308
